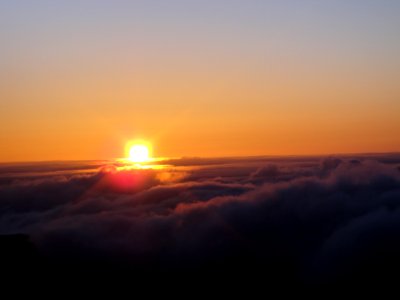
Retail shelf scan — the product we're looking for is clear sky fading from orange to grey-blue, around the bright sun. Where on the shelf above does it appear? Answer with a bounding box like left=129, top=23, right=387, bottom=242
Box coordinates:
left=0, top=0, right=400, bottom=161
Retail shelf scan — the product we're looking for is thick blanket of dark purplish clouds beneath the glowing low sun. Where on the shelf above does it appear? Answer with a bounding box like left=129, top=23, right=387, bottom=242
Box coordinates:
left=0, top=157, right=400, bottom=284
